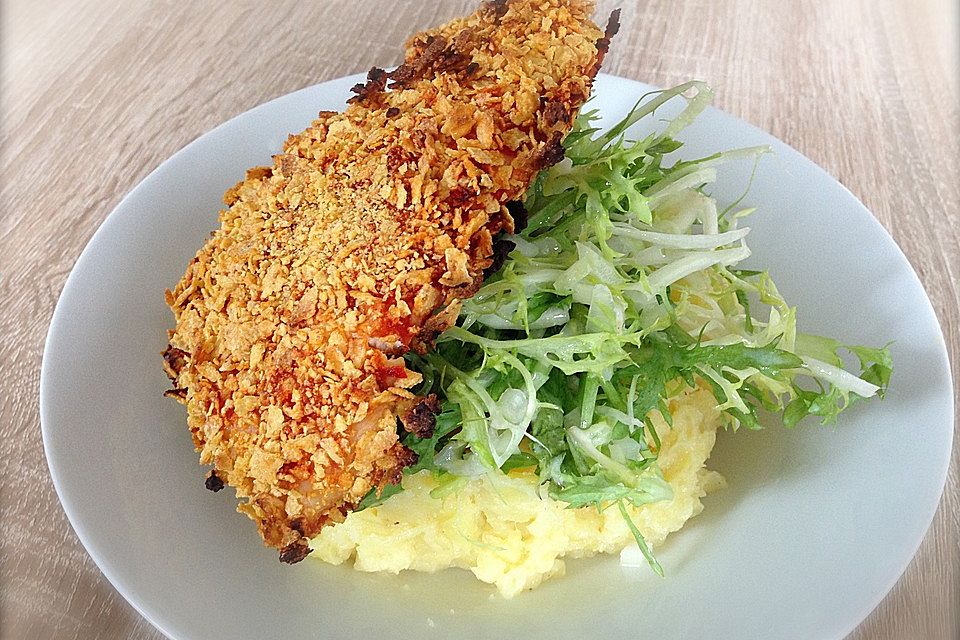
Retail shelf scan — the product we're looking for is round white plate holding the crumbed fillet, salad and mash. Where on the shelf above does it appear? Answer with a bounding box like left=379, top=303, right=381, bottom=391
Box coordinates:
left=40, top=76, right=953, bottom=640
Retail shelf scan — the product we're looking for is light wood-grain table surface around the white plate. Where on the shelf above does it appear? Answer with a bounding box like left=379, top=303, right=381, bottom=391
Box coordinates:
left=0, top=0, right=960, bottom=639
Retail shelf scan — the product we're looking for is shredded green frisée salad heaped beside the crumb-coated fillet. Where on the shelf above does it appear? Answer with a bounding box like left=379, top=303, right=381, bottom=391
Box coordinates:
left=360, top=82, right=893, bottom=575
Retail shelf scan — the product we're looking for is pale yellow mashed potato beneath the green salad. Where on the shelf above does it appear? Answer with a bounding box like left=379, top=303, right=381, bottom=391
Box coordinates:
left=310, top=390, right=724, bottom=598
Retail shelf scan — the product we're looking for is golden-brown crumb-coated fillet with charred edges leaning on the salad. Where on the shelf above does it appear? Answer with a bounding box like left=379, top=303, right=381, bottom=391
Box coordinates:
left=164, top=0, right=616, bottom=562
